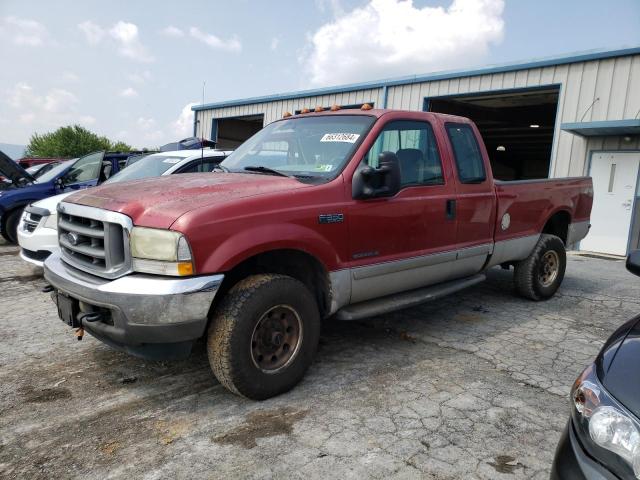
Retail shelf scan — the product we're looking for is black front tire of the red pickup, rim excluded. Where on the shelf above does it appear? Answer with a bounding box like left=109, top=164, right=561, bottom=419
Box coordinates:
left=207, top=274, right=320, bottom=400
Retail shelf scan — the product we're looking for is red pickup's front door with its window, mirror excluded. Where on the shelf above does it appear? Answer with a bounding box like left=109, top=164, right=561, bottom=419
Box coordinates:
left=348, top=114, right=456, bottom=303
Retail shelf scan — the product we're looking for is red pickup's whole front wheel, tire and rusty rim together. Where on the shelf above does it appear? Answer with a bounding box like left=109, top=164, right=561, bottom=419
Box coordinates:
left=207, top=274, right=320, bottom=400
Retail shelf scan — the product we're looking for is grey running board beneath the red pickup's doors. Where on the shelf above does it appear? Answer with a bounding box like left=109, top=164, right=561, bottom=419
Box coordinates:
left=336, top=273, right=486, bottom=320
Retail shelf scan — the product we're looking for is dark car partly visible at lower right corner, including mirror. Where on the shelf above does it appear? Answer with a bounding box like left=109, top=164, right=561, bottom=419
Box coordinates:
left=551, top=250, right=640, bottom=480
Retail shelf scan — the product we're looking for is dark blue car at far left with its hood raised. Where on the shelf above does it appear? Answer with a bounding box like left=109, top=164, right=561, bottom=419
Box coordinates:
left=0, top=151, right=131, bottom=244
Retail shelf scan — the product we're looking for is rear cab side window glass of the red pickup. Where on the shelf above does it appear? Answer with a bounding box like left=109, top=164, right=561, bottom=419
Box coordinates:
left=446, top=123, right=487, bottom=183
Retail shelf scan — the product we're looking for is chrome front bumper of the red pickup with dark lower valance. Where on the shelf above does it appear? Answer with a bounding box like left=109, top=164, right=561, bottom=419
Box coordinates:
left=44, top=253, right=224, bottom=358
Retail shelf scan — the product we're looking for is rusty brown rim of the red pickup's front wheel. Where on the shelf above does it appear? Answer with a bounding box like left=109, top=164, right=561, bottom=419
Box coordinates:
left=251, top=305, right=302, bottom=373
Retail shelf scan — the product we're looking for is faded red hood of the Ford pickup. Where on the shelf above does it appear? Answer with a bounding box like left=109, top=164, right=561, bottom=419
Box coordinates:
left=65, top=173, right=309, bottom=228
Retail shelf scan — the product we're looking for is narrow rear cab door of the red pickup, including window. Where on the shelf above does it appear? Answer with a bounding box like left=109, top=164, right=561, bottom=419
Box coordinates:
left=444, top=122, right=496, bottom=276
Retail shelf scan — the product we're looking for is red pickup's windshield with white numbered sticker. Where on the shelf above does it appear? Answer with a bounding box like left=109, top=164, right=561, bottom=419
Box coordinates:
left=222, top=115, right=375, bottom=181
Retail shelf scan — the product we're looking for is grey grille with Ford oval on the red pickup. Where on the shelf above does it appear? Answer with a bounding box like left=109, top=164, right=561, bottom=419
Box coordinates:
left=58, top=203, right=132, bottom=278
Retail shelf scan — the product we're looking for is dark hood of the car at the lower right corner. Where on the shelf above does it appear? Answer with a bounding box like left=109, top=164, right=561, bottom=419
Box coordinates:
left=596, top=316, right=640, bottom=418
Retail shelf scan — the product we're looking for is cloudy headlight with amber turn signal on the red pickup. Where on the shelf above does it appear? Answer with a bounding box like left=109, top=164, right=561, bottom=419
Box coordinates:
left=131, top=227, right=194, bottom=276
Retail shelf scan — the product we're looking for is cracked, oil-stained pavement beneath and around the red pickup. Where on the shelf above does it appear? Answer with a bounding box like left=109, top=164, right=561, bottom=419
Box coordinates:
left=0, top=238, right=640, bottom=480
